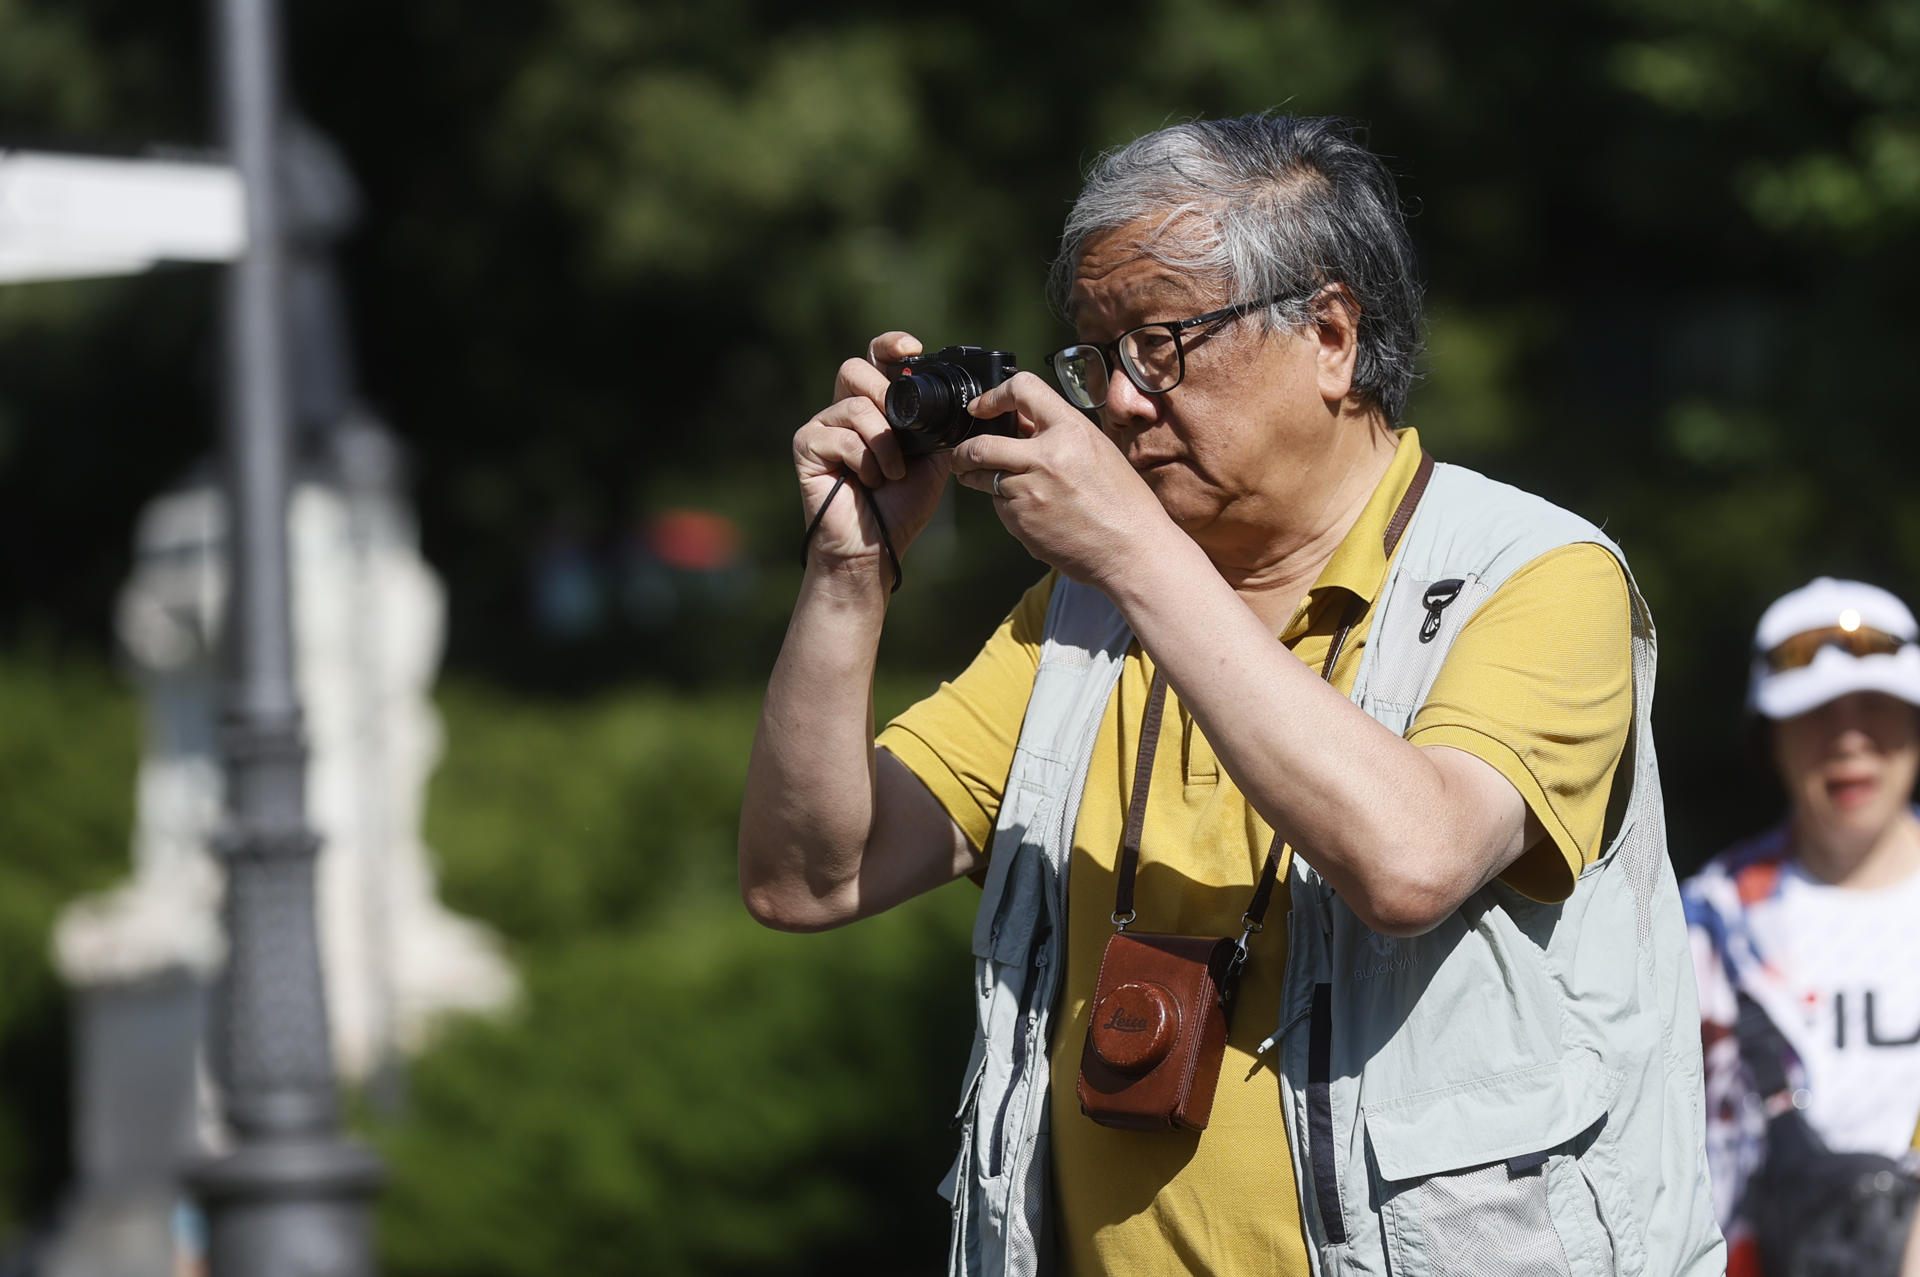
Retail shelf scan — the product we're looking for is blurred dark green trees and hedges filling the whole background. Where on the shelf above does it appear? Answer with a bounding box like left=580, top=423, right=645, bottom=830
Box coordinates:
left=0, top=0, right=1920, bottom=1273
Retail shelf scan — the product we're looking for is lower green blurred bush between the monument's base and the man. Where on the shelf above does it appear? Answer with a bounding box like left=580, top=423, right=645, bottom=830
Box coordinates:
left=380, top=887, right=972, bottom=1277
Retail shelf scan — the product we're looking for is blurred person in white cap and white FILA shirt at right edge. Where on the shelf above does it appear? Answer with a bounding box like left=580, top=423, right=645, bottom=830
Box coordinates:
left=1682, top=576, right=1920, bottom=1277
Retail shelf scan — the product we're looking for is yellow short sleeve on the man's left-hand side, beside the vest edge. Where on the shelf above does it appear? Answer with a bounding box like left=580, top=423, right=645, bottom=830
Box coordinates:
left=876, top=572, right=1054, bottom=855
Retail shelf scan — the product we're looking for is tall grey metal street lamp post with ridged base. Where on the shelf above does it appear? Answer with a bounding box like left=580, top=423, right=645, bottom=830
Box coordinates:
left=190, top=0, right=380, bottom=1277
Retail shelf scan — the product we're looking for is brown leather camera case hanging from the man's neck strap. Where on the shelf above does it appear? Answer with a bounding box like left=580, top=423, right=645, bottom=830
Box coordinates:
left=1077, top=931, right=1235, bottom=1131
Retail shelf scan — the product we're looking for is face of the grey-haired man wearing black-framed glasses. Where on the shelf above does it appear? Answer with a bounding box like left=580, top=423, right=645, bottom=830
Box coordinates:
left=1071, top=225, right=1338, bottom=540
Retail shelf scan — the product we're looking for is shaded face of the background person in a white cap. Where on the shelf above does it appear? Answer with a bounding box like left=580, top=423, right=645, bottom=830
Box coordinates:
left=1774, top=691, right=1920, bottom=853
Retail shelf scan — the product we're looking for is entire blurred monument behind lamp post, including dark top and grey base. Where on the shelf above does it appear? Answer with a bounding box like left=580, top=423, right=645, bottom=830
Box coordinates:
left=46, top=127, right=515, bottom=1277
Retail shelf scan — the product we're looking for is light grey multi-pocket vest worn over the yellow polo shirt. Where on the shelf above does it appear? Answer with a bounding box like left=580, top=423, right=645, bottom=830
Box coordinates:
left=941, top=465, right=1726, bottom=1277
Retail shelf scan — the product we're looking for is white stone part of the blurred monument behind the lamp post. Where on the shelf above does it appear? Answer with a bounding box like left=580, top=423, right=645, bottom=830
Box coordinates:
left=56, top=422, right=513, bottom=1083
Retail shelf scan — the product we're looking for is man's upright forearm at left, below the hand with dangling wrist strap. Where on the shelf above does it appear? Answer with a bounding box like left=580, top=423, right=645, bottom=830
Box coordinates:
left=739, top=563, right=887, bottom=926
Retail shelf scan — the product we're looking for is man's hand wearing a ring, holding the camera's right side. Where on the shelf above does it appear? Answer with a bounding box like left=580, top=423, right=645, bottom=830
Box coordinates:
left=952, top=373, right=1175, bottom=586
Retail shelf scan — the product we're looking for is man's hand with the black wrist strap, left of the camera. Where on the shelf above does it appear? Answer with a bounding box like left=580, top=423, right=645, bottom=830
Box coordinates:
left=793, top=332, right=952, bottom=584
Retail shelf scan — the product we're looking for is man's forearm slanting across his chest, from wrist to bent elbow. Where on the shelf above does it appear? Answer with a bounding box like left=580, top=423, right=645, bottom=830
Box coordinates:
left=1108, top=534, right=1524, bottom=931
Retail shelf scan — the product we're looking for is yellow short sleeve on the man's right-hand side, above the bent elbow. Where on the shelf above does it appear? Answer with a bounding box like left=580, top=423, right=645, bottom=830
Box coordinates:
left=1407, top=542, right=1634, bottom=901
